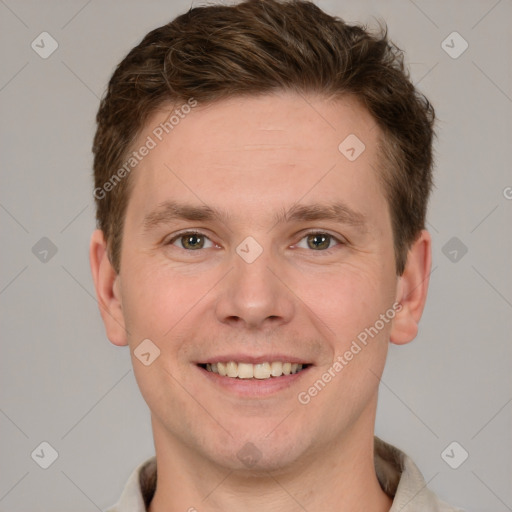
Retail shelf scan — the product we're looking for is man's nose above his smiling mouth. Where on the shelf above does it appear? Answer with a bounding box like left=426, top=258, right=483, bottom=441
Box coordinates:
left=215, top=246, right=295, bottom=330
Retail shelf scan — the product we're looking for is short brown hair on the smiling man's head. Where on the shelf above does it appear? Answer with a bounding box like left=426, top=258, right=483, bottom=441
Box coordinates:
left=93, top=0, right=434, bottom=275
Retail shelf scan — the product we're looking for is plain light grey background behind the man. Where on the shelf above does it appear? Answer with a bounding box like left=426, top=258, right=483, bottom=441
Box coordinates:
left=0, top=0, right=512, bottom=512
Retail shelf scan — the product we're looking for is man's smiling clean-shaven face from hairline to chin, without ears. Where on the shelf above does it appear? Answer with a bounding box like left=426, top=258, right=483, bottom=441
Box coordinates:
left=97, top=93, right=412, bottom=469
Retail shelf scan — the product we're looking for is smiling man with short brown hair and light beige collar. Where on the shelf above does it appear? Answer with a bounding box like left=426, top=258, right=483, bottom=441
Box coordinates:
left=90, top=0, right=462, bottom=512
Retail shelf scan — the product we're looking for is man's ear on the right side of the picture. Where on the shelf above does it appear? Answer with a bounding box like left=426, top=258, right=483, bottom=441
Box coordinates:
left=390, top=230, right=432, bottom=345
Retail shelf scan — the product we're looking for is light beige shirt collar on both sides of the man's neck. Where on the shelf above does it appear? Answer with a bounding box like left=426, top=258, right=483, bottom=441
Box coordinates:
left=107, top=437, right=462, bottom=512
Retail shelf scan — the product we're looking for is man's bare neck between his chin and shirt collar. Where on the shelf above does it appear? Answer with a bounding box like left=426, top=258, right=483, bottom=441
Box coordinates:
left=149, top=419, right=392, bottom=512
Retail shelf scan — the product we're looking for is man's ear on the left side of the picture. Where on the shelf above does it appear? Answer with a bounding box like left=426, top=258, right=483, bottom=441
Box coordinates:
left=89, top=229, right=128, bottom=346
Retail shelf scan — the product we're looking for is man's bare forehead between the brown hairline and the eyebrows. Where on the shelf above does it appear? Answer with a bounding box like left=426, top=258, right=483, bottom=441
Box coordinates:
left=128, top=93, right=382, bottom=228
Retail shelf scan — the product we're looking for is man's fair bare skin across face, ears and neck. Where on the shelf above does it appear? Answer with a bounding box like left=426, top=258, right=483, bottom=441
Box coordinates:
left=90, top=92, right=431, bottom=512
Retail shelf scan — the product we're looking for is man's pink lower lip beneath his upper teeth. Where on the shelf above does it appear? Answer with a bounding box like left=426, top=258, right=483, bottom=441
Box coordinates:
left=196, top=366, right=311, bottom=398
